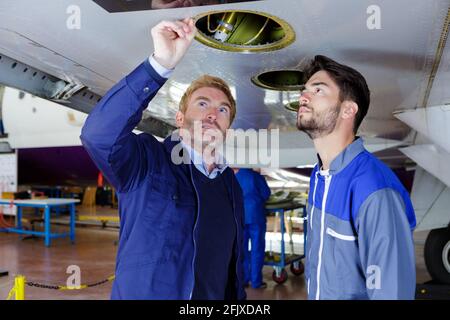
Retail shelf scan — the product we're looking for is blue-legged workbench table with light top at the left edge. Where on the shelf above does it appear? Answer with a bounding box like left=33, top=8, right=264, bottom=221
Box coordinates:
left=0, top=198, right=80, bottom=247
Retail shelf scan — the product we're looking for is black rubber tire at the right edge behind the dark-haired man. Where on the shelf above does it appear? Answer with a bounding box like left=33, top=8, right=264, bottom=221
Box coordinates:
left=424, top=228, right=450, bottom=284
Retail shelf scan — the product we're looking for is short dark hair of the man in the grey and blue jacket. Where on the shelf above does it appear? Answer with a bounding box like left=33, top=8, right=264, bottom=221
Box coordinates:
left=304, top=55, right=370, bottom=134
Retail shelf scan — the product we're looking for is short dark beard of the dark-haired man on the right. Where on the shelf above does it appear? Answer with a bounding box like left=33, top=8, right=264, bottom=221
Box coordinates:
left=297, top=105, right=341, bottom=140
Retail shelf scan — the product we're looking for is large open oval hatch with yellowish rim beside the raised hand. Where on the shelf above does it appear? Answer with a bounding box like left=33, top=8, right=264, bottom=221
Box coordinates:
left=195, top=10, right=295, bottom=53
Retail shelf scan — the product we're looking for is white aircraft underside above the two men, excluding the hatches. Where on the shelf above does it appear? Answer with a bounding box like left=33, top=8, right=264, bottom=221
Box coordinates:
left=0, top=0, right=450, bottom=238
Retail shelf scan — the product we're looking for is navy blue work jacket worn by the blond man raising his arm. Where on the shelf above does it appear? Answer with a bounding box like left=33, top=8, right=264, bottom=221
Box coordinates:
left=80, top=60, right=245, bottom=299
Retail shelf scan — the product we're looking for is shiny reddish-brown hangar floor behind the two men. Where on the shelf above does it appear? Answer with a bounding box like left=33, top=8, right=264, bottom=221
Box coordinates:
left=0, top=214, right=430, bottom=300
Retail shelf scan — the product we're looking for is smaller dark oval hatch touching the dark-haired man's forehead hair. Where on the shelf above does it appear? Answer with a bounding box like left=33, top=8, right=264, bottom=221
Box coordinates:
left=252, top=69, right=305, bottom=91
